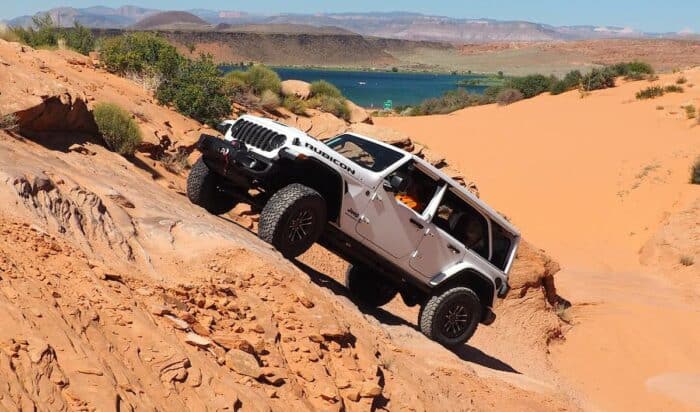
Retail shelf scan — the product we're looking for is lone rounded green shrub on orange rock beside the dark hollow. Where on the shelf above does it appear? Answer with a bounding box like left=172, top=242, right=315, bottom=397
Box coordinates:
left=93, top=103, right=142, bottom=156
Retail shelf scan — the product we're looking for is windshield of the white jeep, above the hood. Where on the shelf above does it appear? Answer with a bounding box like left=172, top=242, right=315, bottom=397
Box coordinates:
left=326, top=134, right=403, bottom=172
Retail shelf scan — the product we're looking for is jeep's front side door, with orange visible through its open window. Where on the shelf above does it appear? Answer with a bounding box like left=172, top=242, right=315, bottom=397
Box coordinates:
left=356, top=159, right=439, bottom=259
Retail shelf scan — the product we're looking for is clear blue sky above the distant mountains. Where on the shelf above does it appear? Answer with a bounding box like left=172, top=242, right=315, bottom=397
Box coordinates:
left=0, top=0, right=700, bottom=33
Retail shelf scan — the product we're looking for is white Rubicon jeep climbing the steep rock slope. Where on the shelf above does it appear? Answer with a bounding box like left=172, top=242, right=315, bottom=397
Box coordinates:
left=187, top=115, right=520, bottom=346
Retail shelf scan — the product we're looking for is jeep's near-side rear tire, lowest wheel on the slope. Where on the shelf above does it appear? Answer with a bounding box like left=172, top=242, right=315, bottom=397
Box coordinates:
left=418, top=287, right=483, bottom=348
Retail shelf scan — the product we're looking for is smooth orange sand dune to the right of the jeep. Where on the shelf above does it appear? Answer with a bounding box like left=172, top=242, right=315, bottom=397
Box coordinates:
left=375, top=69, right=700, bottom=410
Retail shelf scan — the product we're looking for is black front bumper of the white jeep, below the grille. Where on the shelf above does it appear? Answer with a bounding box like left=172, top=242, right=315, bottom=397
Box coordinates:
left=196, top=134, right=274, bottom=181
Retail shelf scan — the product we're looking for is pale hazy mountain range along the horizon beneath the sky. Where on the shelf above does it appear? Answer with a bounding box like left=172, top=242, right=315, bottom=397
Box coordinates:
left=8, top=6, right=682, bottom=43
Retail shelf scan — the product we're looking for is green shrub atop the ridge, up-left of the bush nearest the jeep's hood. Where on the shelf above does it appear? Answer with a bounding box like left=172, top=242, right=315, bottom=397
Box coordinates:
left=100, top=32, right=185, bottom=79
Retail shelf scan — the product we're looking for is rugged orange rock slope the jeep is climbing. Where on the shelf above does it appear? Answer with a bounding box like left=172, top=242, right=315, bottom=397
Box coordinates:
left=0, top=41, right=575, bottom=411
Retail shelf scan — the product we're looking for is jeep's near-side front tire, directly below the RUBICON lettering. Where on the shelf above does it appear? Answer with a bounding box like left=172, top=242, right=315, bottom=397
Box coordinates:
left=258, top=183, right=326, bottom=259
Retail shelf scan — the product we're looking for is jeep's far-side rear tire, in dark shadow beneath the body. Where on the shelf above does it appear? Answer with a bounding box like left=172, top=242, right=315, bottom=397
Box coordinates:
left=345, top=265, right=399, bottom=308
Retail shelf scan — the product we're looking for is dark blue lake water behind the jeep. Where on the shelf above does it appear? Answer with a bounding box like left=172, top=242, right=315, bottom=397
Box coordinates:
left=223, top=67, right=486, bottom=108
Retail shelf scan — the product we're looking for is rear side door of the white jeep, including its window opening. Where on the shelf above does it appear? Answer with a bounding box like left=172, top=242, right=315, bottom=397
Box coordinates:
left=409, top=187, right=490, bottom=278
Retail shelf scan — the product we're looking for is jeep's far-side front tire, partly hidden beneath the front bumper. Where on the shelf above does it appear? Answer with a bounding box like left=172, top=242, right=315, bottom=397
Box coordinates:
left=187, top=158, right=236, bottom=215
